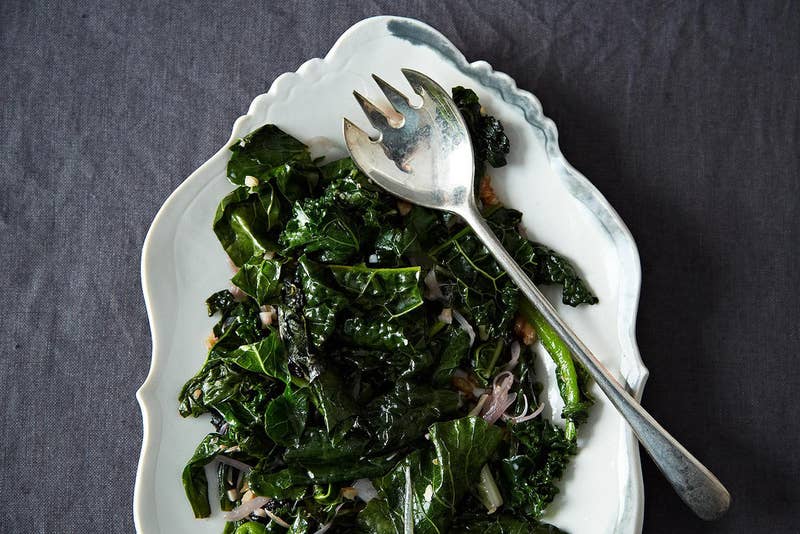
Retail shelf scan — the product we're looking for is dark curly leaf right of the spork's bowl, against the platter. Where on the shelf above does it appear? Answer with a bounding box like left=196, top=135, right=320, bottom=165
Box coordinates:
left=453, top=86, right=511, bottom=179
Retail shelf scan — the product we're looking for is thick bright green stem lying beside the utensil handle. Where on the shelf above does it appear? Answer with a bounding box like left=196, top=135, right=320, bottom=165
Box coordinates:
left=520, top=300, right=581, bottom=440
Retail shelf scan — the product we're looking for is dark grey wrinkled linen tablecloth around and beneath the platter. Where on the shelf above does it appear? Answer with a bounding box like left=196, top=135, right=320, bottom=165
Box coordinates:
left=0, top=0, right=800, bottom=533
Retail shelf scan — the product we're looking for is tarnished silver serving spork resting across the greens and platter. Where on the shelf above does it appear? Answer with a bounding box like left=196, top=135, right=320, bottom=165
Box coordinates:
left=344, top=69, right=730, bottom=520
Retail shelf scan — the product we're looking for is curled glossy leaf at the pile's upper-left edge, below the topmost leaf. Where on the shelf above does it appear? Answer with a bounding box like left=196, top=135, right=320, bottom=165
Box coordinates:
left=213, top=183, right=285, bottom=267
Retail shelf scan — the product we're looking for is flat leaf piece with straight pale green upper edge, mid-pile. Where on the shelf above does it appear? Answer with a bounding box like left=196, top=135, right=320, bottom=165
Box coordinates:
left=330, top=264, right=422, bottom=317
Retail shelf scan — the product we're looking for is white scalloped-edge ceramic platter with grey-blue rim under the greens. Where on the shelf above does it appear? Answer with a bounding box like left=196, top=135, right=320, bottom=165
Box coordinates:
left=134, top=17, right=647, bottom=534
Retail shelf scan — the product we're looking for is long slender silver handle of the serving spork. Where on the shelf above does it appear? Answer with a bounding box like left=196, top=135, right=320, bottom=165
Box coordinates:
left=459, top=205, right=731, bottom=520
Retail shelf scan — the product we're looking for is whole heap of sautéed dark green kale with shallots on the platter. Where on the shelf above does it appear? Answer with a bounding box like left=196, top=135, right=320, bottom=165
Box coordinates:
left=179, top=87, right=597, bottom=534
